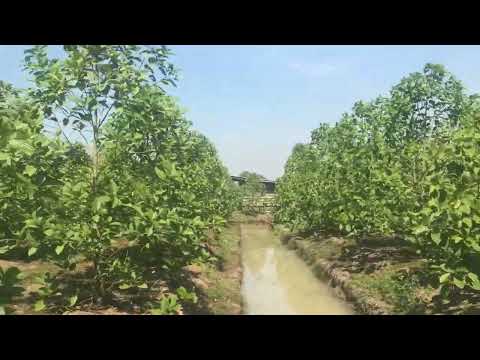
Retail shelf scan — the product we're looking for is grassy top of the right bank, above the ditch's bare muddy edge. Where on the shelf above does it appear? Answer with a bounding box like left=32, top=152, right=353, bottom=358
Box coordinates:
left=275, top=226, right=435, bottom=314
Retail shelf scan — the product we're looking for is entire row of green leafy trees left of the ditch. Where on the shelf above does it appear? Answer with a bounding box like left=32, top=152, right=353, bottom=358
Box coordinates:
left=0, top=46, right=238, bottom=312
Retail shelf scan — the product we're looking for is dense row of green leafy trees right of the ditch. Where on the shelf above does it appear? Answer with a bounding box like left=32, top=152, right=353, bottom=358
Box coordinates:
left=276, top=64, right=480, bottom=290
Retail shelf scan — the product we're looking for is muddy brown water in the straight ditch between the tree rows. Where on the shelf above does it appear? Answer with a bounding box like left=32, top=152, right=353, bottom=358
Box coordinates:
left=241, top=224, right=353, bottom=315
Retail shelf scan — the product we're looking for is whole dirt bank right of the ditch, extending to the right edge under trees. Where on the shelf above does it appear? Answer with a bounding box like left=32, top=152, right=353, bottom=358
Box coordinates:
left=275, top=225, right=480, bottom=315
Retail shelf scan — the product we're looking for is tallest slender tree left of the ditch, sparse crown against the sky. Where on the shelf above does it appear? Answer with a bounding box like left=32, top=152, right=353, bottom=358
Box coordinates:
left=20, top=45, right=180, bottom=296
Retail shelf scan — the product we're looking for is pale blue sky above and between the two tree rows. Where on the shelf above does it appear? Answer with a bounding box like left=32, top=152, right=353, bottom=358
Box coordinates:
left=0, top=45, right=480, bottom=178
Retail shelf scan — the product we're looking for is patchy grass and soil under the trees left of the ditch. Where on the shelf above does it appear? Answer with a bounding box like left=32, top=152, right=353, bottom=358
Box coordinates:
left=0, top=224, right=241, bottom=314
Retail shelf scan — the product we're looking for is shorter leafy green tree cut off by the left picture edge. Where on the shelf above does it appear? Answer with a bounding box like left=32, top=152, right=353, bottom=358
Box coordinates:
left=0, top=87, right=66, bottom=254
